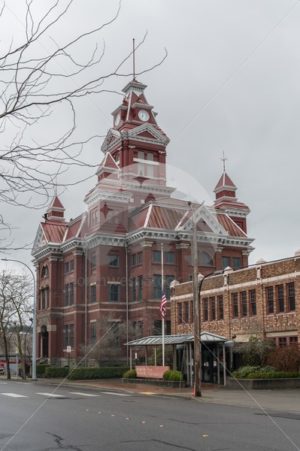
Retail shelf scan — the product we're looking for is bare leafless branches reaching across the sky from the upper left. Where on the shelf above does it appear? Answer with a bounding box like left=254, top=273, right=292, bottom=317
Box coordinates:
left=0, top=0, right=166, bottom=207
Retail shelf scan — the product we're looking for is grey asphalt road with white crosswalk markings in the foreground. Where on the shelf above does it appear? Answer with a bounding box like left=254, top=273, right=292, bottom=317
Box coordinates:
left=0, top=382, right=300, bottom=451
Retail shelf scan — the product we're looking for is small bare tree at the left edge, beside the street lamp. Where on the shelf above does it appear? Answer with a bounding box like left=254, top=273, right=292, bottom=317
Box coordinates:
left=0, top=271, right=32, bottom=379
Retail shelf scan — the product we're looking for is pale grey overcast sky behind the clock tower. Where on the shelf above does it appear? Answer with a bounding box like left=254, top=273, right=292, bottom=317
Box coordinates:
left=1, top=0, right=300, bottom=274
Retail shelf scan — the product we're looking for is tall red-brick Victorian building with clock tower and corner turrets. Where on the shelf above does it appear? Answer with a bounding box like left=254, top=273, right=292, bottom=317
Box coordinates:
left=32, top=80, right=252, bottom=368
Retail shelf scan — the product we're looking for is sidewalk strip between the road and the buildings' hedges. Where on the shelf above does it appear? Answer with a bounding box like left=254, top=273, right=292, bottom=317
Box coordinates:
left=35, top=379, right=300, bottom=414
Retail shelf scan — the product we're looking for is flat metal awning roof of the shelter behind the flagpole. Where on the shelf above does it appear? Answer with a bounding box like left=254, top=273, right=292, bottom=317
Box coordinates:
left=126, top=332, right=227, bottom=346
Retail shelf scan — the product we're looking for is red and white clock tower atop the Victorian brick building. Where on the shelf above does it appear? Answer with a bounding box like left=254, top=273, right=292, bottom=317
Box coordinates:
left=102, top=79, right=173, bottom=206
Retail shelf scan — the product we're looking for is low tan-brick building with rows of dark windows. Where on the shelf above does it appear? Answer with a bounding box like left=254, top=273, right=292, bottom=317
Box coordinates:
left=171, top=253, right=300, bottom=346
